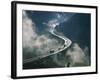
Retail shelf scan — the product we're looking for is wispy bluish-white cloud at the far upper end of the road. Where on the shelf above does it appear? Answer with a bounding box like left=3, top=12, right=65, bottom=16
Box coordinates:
left=43, top=13, right=75, bottom=29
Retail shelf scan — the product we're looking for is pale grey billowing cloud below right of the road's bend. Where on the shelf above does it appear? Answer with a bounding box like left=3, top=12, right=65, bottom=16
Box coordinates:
left=66, top=43, right=85, bottom=64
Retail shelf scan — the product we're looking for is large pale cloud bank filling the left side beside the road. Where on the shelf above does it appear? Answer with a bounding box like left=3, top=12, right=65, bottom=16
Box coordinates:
left=22, top=11, right=61, bottom=59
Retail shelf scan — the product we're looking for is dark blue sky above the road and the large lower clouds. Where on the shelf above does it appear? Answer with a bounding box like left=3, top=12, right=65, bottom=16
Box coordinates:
left=26, top=11, right=91, bottom=46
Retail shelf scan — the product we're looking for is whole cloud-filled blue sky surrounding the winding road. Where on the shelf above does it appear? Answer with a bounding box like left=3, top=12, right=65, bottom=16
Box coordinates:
left=23, top=10, right=91, bottom=69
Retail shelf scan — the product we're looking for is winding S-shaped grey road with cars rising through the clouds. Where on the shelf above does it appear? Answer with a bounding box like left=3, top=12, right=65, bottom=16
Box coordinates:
left=23, top=26, right=72, bottom=63
